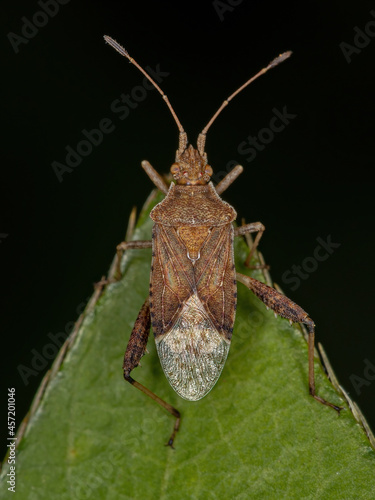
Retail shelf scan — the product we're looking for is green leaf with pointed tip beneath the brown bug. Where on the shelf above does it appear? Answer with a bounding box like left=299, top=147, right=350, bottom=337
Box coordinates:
left=0, top=189, right=375, bottom=500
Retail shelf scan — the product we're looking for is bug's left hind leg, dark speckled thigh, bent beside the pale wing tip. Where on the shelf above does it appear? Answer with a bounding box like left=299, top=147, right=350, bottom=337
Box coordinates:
left=123, top=298, right=180, bottom=448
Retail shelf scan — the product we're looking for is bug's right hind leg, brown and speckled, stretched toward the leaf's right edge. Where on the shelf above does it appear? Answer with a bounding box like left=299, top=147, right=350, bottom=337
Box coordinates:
left=236, top=273, right=342, bottom=413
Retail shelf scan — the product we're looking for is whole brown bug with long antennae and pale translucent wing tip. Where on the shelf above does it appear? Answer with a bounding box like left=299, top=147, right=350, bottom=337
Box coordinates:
left=104, top=36, right=341, bottom=447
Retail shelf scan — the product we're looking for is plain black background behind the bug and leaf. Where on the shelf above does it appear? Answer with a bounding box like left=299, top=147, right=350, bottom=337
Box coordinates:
left=0, top=0, right=375, bottom=454
